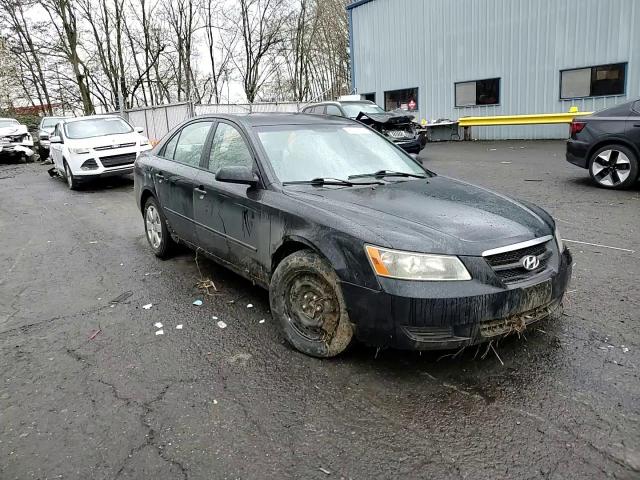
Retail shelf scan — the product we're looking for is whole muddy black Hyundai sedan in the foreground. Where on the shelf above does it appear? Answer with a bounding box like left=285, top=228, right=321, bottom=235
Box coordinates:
left=135, top=114, right=571, bottom=357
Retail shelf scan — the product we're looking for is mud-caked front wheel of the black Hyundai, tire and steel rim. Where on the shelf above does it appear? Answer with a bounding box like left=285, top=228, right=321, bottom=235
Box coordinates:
left=269, top=250, right=354, bottom=358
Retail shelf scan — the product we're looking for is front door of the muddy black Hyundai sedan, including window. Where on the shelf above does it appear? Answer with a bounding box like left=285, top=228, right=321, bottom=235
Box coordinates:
left=194, top=121, right=269, bottom=278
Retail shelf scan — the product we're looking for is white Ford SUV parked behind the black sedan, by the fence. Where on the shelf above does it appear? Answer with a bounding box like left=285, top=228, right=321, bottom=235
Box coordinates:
left=49, top=115, right=151, bottom=190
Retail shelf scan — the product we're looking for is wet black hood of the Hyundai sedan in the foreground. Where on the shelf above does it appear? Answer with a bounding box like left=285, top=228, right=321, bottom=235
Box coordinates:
left=287, top=176, right=553, bottom=255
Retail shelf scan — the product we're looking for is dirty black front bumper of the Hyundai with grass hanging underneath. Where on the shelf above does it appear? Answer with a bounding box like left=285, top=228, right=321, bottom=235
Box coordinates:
left=342, top=249, right=572, bottom=350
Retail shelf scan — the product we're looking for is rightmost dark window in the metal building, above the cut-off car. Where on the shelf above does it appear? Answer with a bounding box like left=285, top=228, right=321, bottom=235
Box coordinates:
left=560, top=63, right=627, bottom=99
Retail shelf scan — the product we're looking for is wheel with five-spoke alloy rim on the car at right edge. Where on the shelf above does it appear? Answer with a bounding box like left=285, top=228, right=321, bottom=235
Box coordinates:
left=589, top=144, right=638, bottom=189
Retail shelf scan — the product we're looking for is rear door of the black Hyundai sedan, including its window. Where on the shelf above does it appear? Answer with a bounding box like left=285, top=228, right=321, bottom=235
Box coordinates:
left=152, top=119, right=213, bottom=244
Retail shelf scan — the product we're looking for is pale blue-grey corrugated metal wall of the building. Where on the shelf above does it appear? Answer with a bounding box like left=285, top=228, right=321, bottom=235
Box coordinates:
left=351, top=0, right=640, bottom=139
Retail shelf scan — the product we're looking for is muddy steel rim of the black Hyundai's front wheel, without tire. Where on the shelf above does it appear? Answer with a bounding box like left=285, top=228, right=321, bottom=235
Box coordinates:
left=284, top=271, right=340, bottom=342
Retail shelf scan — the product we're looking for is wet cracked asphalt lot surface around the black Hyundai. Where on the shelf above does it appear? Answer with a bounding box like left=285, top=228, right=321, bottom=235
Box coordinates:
left=0, top=142, right=640, bottom=480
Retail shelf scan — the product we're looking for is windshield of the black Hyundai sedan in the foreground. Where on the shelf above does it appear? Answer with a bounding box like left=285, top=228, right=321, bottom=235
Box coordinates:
left=256, top=124, right=425, bottom=183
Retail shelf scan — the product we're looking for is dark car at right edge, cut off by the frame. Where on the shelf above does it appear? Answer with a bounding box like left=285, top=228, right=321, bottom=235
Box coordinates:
left=567, top=100, right=640, bottom=189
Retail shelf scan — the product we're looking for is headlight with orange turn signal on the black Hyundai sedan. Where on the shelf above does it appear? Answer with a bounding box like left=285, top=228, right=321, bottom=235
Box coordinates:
left=365, top=245, right=471, bottom=281
